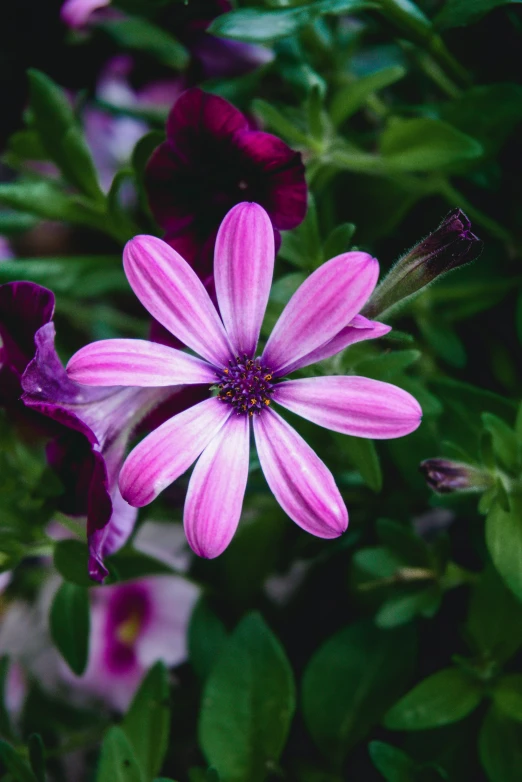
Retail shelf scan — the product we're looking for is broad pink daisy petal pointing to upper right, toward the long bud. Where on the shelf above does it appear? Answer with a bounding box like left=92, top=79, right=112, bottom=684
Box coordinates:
left=263, top=252, right=379, bottom=375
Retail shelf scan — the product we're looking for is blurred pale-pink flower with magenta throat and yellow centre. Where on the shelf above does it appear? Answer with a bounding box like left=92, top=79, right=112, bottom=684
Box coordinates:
left=61, top=576, right=199, bottom=711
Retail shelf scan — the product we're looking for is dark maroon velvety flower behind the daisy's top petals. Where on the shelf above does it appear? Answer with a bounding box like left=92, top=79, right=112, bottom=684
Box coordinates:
left=145, top=88, right=307, bottom=279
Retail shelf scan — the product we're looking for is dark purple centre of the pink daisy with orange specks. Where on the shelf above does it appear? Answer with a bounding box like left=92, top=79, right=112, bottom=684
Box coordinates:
left=217, top=355, right=273, bottom=416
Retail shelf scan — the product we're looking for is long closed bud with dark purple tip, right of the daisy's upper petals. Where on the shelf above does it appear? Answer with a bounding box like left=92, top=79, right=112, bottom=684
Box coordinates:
left=362, top=209, right=482, bottom=318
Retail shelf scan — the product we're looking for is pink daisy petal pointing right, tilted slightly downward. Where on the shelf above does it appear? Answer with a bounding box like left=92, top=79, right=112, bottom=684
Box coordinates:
left=272, top=375, right=422, bottom=440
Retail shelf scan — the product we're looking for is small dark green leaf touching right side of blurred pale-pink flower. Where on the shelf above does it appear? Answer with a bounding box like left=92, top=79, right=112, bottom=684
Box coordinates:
left=188, top=597, right=228, bottom=681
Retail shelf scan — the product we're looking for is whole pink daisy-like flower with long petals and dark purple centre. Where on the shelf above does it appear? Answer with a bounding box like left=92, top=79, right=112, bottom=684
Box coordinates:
left=67, top=203, right=421, bottom=558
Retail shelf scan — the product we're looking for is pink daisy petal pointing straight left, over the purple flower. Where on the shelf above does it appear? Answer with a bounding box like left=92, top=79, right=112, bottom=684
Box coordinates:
left=67, top=339, right=216, bottom=388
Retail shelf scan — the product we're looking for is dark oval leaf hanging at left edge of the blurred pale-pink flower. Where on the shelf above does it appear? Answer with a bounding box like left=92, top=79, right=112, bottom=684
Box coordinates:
left=50, top=581, right=90, bottom=676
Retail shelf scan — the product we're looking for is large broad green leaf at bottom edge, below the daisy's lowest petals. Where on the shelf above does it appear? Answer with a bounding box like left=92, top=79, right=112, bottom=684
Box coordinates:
left=199, top=614, right=295, bottom=782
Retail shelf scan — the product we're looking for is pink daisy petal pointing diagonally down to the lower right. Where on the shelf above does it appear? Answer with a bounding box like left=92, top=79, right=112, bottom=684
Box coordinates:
left=254, top=410, right=348, bottom=538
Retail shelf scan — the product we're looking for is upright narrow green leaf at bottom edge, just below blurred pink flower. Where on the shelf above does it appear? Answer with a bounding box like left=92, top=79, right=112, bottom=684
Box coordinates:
left=121, top=662, right=170, bottom=779
